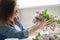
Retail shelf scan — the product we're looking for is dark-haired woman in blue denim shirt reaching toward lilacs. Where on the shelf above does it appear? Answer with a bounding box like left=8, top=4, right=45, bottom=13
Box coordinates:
left=0, top=0, right=50, bottom=40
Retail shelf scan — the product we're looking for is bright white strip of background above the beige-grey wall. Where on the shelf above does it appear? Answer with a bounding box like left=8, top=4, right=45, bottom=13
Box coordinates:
left=17, top=0, right=60, bottom=8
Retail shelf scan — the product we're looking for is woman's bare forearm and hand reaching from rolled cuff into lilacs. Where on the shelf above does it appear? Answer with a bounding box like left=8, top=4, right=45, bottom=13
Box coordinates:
left=28, top=20, right=52, bottom=35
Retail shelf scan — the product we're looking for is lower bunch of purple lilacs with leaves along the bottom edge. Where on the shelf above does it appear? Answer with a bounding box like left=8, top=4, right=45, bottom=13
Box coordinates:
left=32, top=33, right=60, bottom=40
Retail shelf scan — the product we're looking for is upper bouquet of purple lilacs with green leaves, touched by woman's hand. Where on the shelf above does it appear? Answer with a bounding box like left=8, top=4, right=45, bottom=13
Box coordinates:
left=33, top=9, right=60, bottom=30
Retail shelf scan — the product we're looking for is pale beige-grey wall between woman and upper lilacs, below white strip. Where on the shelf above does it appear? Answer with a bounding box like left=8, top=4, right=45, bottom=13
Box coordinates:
left=19, top=5, right=60, bottom=28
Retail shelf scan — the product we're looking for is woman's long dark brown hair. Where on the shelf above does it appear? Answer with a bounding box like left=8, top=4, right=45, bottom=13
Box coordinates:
left=0, top=0, right=16, bottom=25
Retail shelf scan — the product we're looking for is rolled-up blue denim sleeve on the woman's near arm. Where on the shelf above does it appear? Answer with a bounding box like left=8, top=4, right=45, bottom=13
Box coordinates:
left=3, top=28, right=29, bottom=39
